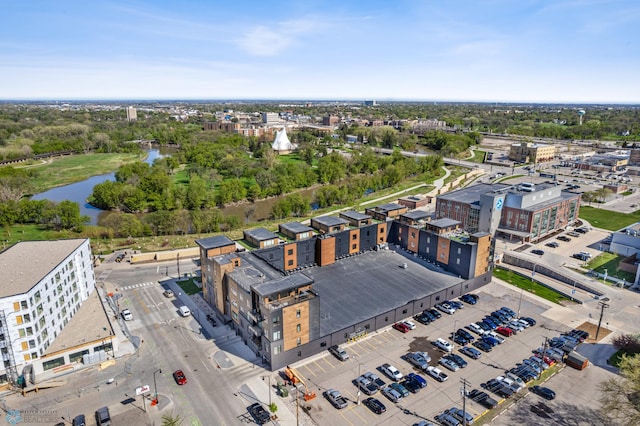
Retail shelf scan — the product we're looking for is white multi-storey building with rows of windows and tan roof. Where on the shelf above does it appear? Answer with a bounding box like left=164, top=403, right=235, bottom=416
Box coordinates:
left=0, top=239, right=100, bottom=384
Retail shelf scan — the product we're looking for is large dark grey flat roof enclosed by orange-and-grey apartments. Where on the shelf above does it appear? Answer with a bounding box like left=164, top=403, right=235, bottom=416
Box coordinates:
left=304, top=250, right=464, bottom=336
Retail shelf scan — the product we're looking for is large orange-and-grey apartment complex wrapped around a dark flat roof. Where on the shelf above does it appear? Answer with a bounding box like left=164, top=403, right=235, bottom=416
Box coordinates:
left=196, top=212, right=493, bottom=370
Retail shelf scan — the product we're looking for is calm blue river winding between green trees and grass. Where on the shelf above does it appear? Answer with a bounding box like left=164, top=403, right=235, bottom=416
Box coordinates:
left=31, top=149, right=163, bottom=225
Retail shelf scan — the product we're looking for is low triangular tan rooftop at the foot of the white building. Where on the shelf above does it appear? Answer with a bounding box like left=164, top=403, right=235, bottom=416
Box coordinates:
left=45, top=290, right=115, bottom=355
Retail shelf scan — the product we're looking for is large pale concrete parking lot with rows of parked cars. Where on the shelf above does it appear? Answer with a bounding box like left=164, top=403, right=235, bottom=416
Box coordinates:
left=284, top=290, right=596, bottom=425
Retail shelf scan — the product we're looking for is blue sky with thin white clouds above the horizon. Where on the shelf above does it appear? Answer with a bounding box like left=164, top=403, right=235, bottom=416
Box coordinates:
left=0, top=0, right=640, bottom=103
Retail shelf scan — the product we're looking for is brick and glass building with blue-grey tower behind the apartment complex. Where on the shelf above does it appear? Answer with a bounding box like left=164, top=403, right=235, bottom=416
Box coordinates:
left=435, top=183, right=580, bottom=241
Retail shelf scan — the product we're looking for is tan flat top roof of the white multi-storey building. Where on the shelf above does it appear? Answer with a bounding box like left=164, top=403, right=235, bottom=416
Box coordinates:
left=0, top=238, right=86, bottom=297
